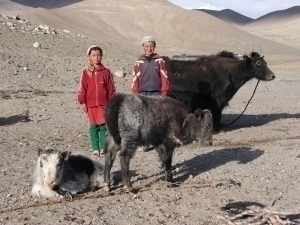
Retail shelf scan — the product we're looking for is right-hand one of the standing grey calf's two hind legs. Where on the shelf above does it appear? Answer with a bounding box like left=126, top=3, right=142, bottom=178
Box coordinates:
left=119, top=138, right=138, bottom=189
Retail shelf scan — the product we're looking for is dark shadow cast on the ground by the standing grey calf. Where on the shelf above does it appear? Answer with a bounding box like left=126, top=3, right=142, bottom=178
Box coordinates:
left=174, top=147, right=264, bottom=182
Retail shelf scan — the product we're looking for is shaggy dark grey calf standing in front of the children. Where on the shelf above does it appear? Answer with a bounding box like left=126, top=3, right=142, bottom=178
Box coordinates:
left=104, top=94, right=213, bottom=191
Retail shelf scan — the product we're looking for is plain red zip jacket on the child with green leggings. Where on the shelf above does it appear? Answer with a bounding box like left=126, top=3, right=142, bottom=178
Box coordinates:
left=77, top=64, right=116, bottom=107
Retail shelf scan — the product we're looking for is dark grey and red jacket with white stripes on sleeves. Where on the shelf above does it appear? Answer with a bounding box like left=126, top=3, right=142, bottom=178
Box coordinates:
left=131, top=53, right=170, bottom=95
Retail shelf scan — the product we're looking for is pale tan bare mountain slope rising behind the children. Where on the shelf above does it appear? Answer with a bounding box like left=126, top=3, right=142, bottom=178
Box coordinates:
left=0, top=0, right=300, bottom=60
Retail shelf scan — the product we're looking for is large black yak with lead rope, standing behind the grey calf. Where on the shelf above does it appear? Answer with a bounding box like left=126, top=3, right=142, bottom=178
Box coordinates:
left=164, top=51, right=275, bottom=131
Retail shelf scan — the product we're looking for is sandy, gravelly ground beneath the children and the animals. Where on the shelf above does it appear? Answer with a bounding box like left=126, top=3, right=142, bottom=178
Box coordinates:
left=0, top=16, right=300, bottom=225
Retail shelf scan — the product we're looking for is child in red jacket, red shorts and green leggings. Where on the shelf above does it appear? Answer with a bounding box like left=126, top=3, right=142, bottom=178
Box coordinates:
left=78, top=45, right=116, bottom=157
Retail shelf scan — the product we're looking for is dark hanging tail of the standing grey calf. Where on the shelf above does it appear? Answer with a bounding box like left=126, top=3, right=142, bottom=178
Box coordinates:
left=105, top=94, right=125, bottom=145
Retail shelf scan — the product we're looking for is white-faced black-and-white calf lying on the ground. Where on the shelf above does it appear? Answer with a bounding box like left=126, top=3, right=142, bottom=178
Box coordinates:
left=31, top=149, right=103, bottom=199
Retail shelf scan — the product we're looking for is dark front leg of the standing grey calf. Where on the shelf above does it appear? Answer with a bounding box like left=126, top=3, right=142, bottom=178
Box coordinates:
left=157, top=140, right=176, bottom=182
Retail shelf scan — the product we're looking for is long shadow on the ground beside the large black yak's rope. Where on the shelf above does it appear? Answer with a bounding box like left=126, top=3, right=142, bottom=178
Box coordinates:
left=222, top=113, right=300, bottom=131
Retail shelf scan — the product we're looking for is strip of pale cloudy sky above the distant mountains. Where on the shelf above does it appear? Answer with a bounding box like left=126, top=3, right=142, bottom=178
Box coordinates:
left=168, top=0, right=300, bottom=19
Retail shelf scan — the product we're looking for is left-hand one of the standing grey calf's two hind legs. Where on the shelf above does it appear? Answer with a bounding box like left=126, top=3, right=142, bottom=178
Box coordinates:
left=104, top=135, right=120, bottom=191
